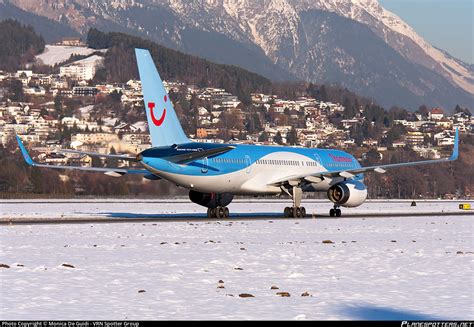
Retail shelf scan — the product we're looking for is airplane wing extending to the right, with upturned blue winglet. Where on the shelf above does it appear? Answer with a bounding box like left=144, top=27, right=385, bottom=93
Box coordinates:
left=269, top=129, right=459, bottom=185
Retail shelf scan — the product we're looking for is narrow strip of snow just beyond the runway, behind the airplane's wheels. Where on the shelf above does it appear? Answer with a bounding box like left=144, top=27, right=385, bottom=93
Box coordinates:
left=0, top=199, right=474, bottom=221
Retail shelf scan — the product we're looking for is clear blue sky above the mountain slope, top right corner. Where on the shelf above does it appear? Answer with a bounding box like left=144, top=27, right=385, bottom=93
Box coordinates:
left=379, top=0, right=474, bottom=64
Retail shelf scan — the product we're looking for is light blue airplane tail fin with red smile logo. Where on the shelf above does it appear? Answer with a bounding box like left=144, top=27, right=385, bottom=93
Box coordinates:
left=135, top=49, right=190, bottom=147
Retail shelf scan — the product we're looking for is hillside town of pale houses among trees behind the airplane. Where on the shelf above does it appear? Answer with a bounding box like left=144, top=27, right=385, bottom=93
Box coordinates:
left=0, top=43, right=474, bottom=169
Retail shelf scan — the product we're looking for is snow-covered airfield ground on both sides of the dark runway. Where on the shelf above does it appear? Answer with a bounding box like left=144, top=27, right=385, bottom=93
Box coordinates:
left=0, top=201, right=474, bottom=320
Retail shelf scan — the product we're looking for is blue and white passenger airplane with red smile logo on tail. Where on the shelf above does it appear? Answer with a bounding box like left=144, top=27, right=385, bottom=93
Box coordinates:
left=17, top=49, right=459, bottom=218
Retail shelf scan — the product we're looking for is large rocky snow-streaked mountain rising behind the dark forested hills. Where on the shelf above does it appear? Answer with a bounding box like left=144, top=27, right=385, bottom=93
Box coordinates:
left=4, top=0, right=474, bottom=109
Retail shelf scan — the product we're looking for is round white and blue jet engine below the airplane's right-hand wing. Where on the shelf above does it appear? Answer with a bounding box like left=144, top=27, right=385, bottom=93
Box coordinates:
left=328, top=181, right=367, bottom=207
